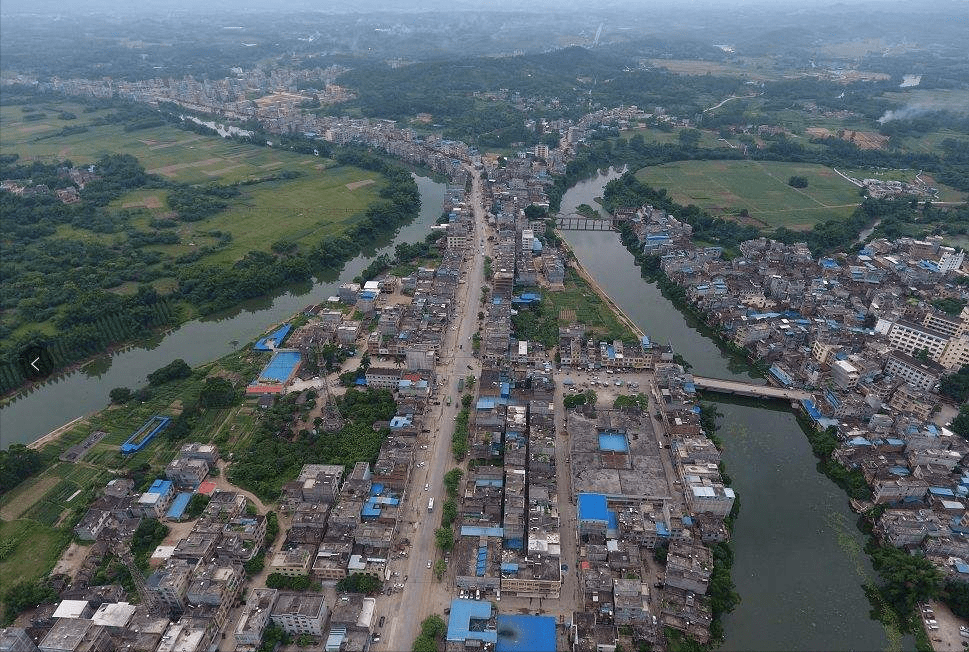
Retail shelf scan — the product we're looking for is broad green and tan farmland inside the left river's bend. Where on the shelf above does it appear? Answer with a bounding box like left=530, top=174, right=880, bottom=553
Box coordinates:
left=0, top=101, right=383, bottom=314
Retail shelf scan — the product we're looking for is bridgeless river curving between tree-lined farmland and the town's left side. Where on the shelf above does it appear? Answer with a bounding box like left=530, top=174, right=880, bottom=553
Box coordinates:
left=0, top=175, right=445, bottom=449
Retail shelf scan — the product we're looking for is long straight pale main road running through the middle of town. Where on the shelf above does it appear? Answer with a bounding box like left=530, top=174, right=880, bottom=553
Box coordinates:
left=376, top=170, right=488, bottom=652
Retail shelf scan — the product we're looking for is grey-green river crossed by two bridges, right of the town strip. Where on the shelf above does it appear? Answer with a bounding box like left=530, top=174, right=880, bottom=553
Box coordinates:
left=561, top=172, right=914, bottom=650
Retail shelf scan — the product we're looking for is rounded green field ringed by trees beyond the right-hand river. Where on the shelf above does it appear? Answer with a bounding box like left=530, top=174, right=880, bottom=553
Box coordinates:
left=636, top=161, right=861, bottom=230
